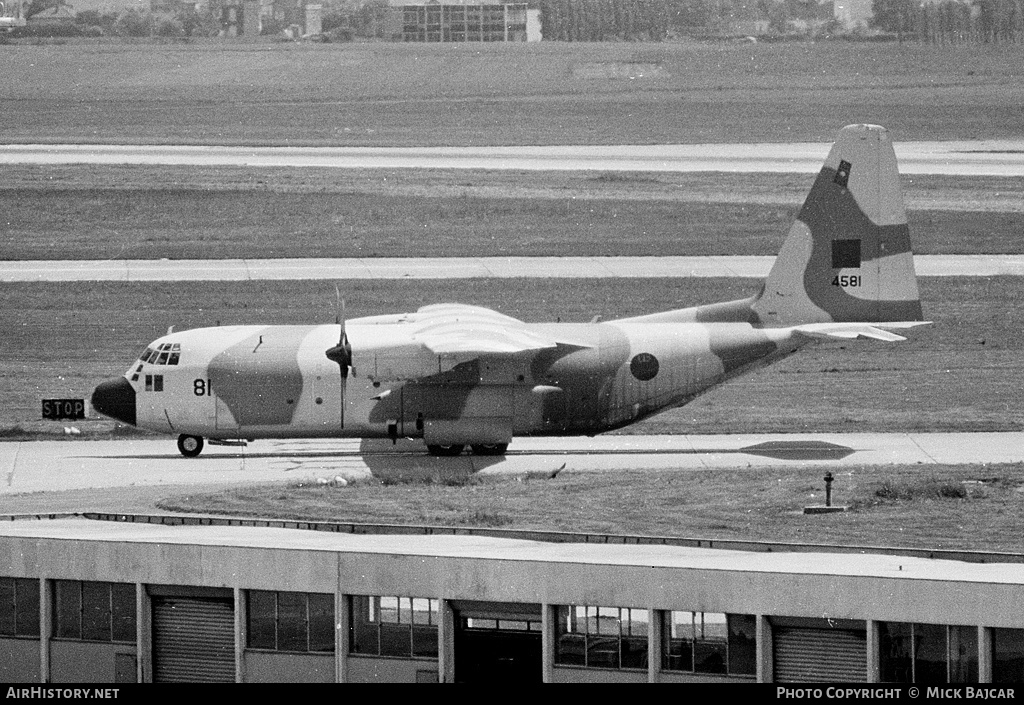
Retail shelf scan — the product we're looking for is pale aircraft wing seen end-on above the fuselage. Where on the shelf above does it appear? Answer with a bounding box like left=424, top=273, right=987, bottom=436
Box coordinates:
left=409, top=303, right=558, bottom=356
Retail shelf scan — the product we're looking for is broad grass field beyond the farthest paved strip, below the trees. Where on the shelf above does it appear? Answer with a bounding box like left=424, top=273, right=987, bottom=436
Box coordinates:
left=0, top=42, right=1024, bottom=146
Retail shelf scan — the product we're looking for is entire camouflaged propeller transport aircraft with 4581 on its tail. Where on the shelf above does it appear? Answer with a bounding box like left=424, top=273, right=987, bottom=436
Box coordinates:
left=92, top=125, right=923, bottom=457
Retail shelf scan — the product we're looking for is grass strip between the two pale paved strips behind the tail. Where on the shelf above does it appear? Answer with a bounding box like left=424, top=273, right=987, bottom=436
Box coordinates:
left=0, top=166, right=1024, bottom=259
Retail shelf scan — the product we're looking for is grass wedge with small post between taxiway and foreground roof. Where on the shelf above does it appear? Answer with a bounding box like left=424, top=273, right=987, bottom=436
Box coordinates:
left=158, top=464, right=1024, bottom=552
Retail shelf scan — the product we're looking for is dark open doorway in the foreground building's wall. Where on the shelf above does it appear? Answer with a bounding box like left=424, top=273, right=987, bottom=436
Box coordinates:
left=452, top=600, right=544, bottom=685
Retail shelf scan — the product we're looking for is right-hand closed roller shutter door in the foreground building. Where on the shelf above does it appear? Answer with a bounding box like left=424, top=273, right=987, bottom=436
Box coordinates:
left=772, top=627, right=867, bottom=682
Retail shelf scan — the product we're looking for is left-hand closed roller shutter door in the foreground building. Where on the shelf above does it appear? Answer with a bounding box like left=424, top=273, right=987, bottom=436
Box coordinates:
left=153, top=597, right=234, bottom=682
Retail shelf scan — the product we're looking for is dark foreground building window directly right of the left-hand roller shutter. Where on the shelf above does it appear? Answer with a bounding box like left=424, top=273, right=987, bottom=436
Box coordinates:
left=248, top=590, right=334, bottom=652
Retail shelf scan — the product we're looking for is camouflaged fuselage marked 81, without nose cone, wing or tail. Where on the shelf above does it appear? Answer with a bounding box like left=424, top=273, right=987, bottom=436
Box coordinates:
left=104, top=317, right=799, bottom=446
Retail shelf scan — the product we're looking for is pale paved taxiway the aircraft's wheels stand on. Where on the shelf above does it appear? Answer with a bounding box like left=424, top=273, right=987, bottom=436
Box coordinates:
left=0, top=432, right=1024, bottom=496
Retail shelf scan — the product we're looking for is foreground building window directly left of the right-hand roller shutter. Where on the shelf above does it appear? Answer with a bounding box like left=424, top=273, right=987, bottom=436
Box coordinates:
left=662, top=611, right=757, bottom=675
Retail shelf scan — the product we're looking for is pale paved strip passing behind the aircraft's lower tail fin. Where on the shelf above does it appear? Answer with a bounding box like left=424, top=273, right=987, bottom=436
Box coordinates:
left=0, top=254, right=1024, bottom=282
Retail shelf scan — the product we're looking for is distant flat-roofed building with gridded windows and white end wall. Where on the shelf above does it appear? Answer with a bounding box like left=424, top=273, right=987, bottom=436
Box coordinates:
left=389, top=0, right=541, bottom=42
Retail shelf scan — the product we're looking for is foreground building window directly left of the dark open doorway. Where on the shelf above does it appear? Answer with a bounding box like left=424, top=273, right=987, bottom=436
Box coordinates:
left=349, top=595, right=438, bottom=659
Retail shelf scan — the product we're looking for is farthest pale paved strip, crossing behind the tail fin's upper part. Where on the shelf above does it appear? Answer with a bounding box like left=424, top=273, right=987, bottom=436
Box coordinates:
left=0, top=139, right=1024, bottom=176
